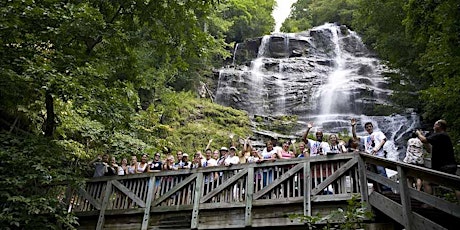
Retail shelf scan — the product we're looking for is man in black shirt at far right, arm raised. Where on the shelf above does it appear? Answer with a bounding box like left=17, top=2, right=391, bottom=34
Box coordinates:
left=416, top=120, right=460, bottom=201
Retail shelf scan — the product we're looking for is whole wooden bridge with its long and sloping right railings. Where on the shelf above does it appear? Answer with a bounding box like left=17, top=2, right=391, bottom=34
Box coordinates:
left=69, top=154, right=460, bottom=229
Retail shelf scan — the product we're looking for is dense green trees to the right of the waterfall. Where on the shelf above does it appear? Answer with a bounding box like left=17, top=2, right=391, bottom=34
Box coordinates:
left=282, top=0, right=460, bottom=156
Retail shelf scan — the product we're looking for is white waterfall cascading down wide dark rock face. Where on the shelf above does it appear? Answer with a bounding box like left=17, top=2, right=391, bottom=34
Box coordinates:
left=216, top=24, right=419, bottom=159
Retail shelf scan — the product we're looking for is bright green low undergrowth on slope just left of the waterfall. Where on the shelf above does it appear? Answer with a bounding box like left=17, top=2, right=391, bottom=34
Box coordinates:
left=144, top=93, right=252, bottom=154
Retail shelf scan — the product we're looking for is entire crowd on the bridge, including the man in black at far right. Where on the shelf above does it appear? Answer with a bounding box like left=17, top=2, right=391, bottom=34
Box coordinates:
left=91, top=119, right=457, bottom=192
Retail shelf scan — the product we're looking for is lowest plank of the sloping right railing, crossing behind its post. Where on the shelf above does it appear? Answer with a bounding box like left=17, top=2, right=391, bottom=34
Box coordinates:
left=369, top=192, right=446, bottom=229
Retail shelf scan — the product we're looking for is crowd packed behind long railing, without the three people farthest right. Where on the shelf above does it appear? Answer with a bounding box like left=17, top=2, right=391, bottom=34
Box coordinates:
left=90, top=123, right=359, bottom=177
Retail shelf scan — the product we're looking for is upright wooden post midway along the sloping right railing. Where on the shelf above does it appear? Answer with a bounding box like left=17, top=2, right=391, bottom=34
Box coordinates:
left=397, top=165, right=413, bottom=230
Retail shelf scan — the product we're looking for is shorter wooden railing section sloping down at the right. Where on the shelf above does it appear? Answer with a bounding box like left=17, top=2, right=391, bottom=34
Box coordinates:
left=360, top=154, right=460, bottom=229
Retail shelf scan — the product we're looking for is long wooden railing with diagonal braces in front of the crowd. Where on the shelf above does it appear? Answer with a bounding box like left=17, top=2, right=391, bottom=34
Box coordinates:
left=69, top=154, right=367, bottom=229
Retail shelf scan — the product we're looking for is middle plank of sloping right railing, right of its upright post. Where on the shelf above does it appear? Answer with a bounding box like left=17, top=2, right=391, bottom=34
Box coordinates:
left=409, top=188, right=460, bottom=218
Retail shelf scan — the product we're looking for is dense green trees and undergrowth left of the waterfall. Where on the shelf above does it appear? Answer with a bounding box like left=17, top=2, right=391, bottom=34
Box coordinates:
left=0, top=0, right=274, bottom=229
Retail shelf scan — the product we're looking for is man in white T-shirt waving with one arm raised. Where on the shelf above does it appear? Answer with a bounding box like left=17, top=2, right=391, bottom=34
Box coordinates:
left=351, top=118, right=391, bottom=192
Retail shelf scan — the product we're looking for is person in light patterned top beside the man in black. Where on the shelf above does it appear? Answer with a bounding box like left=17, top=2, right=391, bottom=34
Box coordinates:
left=403, top=132, right=424, bottom=191
